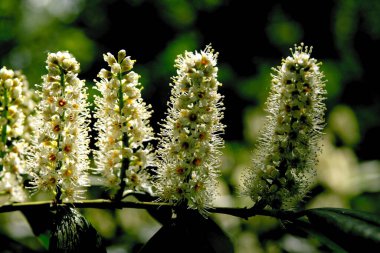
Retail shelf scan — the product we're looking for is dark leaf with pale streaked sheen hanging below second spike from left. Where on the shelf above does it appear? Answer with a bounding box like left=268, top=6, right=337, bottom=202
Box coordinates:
left=49, top=207, right=106, bottom=253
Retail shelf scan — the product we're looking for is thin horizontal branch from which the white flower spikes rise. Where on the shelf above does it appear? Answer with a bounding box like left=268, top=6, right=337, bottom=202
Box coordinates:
left=0, top=199, right=302, bottom=220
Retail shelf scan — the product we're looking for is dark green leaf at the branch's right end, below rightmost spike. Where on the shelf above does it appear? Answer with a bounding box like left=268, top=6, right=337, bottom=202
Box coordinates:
left=305, top=208, right=380, bottom=252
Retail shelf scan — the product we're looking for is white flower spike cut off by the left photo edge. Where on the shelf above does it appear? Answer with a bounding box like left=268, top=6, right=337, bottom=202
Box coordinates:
left=0, top=67, right=34, bottom=202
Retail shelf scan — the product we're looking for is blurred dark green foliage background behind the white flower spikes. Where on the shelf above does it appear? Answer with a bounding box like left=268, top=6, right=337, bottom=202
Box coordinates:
left=0, top=0, right=380, bottom=253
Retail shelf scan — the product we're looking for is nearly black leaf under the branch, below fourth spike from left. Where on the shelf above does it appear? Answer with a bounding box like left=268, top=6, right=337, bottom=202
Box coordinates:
left=140, top=211, right=234, bottom=253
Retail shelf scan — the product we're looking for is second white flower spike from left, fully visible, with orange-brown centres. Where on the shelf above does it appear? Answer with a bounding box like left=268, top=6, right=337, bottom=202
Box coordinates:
left=28, top=52, right=89, bottom=201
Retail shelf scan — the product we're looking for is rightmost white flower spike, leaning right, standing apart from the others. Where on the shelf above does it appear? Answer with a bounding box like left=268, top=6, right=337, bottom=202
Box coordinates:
left=244, top=44, right=326, bottom=208
